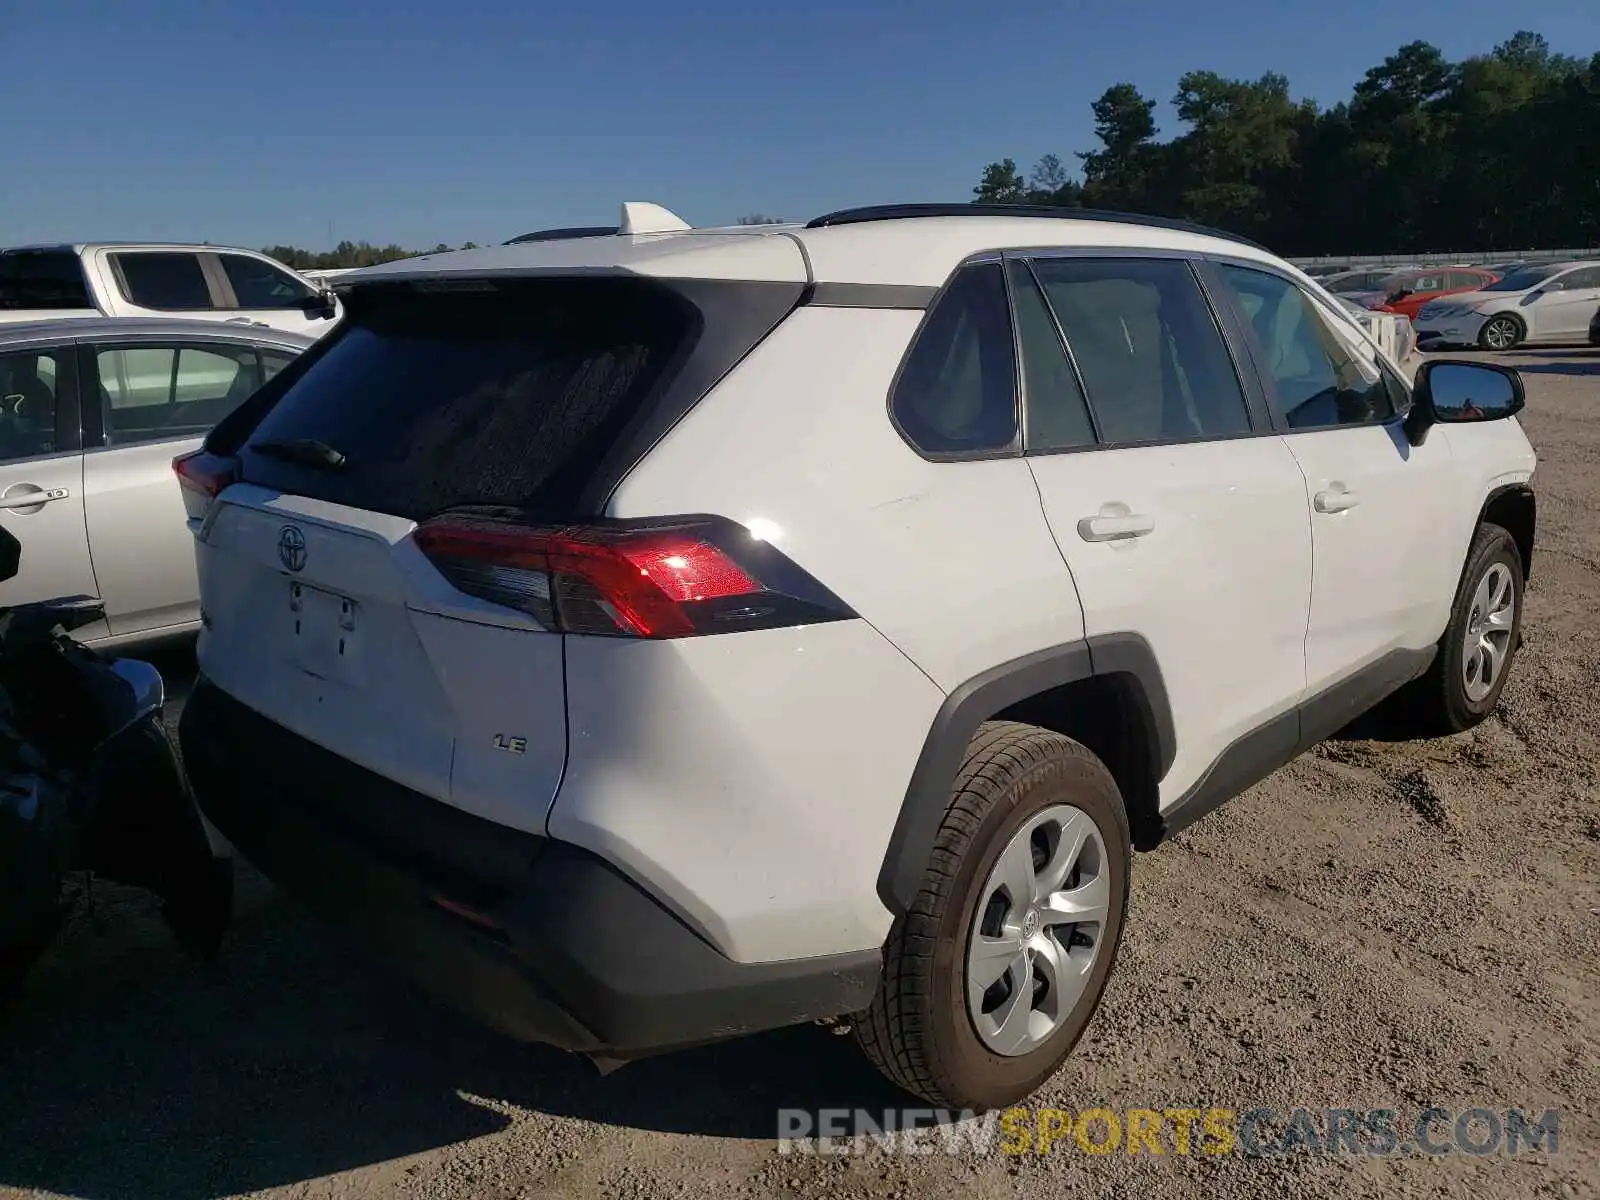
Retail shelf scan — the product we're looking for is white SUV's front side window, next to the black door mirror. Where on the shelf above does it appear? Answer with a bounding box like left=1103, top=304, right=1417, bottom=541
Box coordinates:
left=1221, top=266, right=1395, bottom=429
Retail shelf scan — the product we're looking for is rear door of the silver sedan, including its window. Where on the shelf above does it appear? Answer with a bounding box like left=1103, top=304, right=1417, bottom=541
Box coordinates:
left=80, top=334, right=262, bottom=637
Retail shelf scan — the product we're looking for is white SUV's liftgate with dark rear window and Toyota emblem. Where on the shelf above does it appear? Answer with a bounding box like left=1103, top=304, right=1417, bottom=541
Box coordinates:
left=188, top=278, right=699, bottom=830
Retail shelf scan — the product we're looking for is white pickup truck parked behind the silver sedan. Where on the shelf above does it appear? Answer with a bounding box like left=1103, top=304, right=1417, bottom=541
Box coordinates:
left=0, top=242, right=342, bottom=338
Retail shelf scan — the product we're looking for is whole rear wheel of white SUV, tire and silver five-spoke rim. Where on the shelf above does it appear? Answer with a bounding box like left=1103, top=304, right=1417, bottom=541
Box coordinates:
left=856, top=722, right=1131, bottom=1109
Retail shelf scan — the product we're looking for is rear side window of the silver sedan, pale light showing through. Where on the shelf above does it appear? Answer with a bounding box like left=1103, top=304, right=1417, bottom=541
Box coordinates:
left=94, top=344, right=261, bottom=446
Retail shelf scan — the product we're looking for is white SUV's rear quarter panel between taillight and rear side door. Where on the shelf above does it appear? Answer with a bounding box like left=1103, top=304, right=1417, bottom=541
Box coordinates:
left=610, top=307, right=1083, bottom=690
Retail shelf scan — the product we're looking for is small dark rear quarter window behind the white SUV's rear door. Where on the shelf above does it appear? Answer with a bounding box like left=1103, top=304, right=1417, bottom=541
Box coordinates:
left=891, top=262, right=1016, bottom=454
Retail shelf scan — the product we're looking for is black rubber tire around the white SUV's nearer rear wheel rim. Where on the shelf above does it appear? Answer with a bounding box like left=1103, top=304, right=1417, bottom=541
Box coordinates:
left=854, top=722, right=1131, bottom=1110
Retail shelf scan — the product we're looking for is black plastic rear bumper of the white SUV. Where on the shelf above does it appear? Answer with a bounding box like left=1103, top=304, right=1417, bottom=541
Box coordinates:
left=179, top=677, right=880, bottom=1056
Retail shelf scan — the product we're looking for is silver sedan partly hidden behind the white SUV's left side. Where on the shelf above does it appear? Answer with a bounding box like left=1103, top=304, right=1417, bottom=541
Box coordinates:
left=0, top=317, right=314, bottom=645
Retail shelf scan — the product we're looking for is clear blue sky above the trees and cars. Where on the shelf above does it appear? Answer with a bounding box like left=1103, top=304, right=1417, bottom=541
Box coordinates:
left=0, top=0, right=1600, bottom=248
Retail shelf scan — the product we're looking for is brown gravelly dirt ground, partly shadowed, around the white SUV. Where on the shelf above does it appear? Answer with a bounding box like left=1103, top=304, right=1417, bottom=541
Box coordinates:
left=0, top=350, right=1600, bottom=1200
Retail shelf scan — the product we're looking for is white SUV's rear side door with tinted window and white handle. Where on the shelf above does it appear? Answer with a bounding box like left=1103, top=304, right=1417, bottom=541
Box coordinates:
left=1008, top=256, right=1310, bottom=808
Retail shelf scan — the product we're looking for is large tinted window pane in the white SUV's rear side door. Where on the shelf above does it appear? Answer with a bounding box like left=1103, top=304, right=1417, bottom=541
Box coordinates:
left=1034, top=258, right=1250, bottom=445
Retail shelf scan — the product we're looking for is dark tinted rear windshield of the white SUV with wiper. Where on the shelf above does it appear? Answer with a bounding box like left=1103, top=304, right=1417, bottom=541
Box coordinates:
left=240, top=278, right=701, bottom=520
